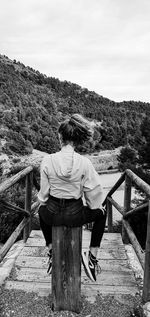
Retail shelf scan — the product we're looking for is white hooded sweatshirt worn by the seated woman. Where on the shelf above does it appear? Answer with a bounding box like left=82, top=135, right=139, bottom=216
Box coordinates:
left=38, top=145, right=103, bottom=209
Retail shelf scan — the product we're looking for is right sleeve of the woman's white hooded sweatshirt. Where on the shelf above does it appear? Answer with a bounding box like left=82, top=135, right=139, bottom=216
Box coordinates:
left=83, top=160, right=103, bottom=209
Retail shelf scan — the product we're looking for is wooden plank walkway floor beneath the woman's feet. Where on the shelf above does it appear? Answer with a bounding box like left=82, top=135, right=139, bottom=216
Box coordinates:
left=2, top=230, right=138, bottom=301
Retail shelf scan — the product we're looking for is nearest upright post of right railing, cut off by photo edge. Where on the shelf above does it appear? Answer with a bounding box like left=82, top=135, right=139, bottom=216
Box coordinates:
left=142, top=200, right=150, bottom=303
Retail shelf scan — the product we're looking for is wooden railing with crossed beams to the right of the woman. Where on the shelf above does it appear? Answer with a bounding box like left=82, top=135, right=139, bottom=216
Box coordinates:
left=103, top=169, right=150, bottom=302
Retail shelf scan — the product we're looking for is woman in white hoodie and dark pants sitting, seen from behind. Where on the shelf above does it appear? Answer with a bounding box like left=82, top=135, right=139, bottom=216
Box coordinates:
left=38, top=114, right=106, bottom=281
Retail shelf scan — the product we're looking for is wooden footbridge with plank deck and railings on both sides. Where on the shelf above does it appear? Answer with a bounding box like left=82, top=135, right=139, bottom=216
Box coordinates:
left=0, top=167, right=150, bottom=312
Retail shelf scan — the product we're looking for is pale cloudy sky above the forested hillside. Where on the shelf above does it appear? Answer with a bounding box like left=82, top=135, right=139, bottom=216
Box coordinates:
left=0, top=0, right=150, bottom=102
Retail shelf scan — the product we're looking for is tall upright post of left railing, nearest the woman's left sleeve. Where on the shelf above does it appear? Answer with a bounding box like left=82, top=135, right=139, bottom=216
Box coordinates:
left=23, top=172, right=33, bottom=241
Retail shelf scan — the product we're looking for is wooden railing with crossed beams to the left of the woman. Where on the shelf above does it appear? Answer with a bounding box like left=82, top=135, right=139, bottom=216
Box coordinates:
left=0, top=166, right=39, bottom=262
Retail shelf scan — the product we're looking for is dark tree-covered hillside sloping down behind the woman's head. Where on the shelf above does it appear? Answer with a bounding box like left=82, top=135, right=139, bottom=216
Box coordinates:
left=0, top=55, right=150, bottom=154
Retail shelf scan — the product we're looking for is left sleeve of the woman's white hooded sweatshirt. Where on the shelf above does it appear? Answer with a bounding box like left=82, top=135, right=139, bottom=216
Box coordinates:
left=38, top=158, right=50, bottom=205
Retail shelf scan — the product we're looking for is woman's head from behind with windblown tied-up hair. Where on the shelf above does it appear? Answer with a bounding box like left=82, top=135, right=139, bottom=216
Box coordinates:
left=58, top=114, right=93, bottom=146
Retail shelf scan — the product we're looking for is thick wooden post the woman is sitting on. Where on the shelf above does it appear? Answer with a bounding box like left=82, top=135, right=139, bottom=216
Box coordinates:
left=52, top=226, right=82, bottom=313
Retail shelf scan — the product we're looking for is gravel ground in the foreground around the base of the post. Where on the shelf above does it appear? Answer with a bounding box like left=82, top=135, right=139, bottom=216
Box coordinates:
left=0, top=287, right=143, bottom=317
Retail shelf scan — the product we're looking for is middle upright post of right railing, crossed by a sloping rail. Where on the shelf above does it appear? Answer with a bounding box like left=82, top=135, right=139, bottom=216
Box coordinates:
left=122, top=175, right=132, bottom=244
